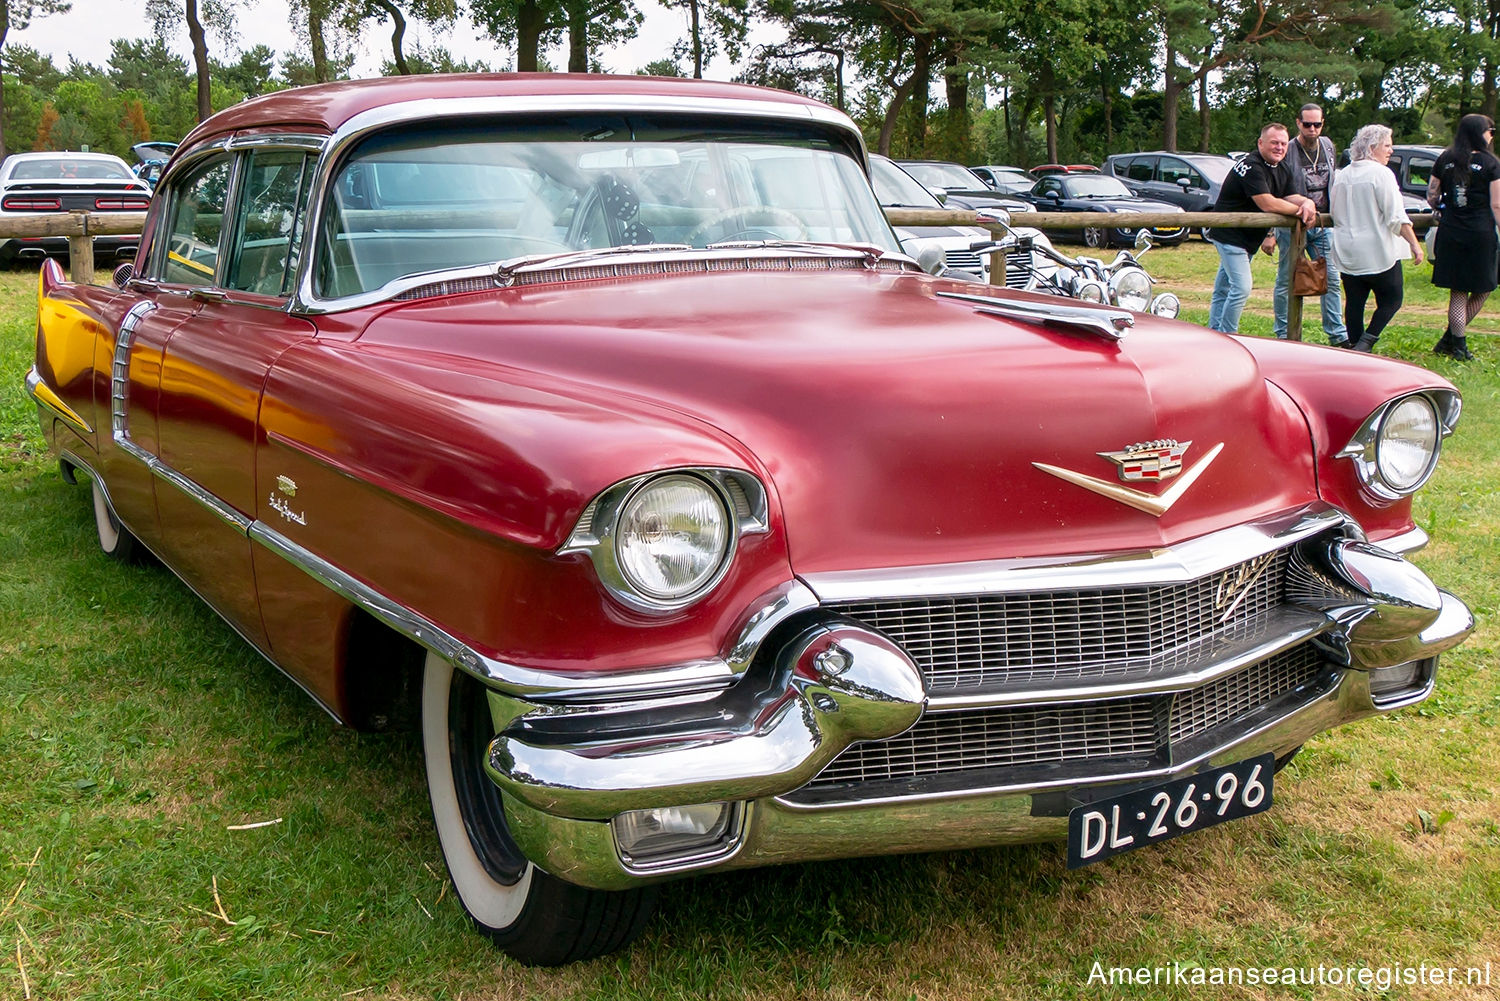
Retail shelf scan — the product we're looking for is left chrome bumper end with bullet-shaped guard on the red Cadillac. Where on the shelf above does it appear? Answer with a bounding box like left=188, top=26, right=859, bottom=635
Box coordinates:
left=486, top=620, right=927, bottom=819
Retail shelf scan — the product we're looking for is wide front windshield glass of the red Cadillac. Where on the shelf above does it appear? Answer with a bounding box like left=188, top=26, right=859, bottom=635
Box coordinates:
left=315, top=116, right=899, bottom=299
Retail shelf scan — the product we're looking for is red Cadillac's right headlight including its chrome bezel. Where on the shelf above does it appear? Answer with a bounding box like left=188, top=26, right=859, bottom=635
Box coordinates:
left=1340, top=390, right=1460, bottom=501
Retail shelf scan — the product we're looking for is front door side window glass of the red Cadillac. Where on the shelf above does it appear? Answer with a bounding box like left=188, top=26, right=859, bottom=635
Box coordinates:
left=225, top=150, right=314, bottom=296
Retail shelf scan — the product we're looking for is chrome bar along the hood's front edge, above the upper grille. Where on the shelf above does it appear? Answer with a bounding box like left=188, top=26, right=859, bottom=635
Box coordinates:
left=803, top=504, right=1362, bottom=603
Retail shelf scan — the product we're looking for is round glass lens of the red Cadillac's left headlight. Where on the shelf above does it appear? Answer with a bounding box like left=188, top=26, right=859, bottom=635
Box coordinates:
left=615, top=474, right=734, bottom=603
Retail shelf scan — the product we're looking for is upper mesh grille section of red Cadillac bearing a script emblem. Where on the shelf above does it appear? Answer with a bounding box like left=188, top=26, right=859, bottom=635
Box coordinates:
left=830, top=551, right=1287, bottom=695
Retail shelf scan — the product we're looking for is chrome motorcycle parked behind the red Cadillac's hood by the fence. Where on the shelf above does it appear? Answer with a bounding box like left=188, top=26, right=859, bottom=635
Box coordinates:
left=942, top=219, right=1182, bottom=320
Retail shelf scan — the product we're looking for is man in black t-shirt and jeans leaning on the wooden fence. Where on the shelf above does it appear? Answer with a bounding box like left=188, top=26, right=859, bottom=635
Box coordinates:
left=1208, top=123, right=1317, bottom=333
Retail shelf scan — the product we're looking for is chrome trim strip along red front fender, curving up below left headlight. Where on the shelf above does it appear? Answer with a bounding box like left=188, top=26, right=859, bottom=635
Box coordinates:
left=249, top=521, right=810, bottom=704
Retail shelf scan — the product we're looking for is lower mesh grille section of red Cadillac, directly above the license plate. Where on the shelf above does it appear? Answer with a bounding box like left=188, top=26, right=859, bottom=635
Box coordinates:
left=789, top=644, right=1335, bottom=800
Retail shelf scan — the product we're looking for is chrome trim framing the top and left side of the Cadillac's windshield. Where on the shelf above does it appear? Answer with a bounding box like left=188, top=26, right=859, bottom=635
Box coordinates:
left=290, top=93, right=870, bottom=315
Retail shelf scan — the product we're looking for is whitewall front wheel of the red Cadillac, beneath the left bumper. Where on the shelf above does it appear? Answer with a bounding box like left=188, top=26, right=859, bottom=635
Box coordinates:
left=422, top=653, right=656, bottom=966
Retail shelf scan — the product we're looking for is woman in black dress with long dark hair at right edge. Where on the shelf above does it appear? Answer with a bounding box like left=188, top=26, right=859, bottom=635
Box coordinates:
left=1427, top=114, right=1500, bottom=362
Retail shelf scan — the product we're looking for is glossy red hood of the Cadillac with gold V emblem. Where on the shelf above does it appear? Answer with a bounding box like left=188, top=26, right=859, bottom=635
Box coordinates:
left=360, top=272, right=1316, bottom=573
